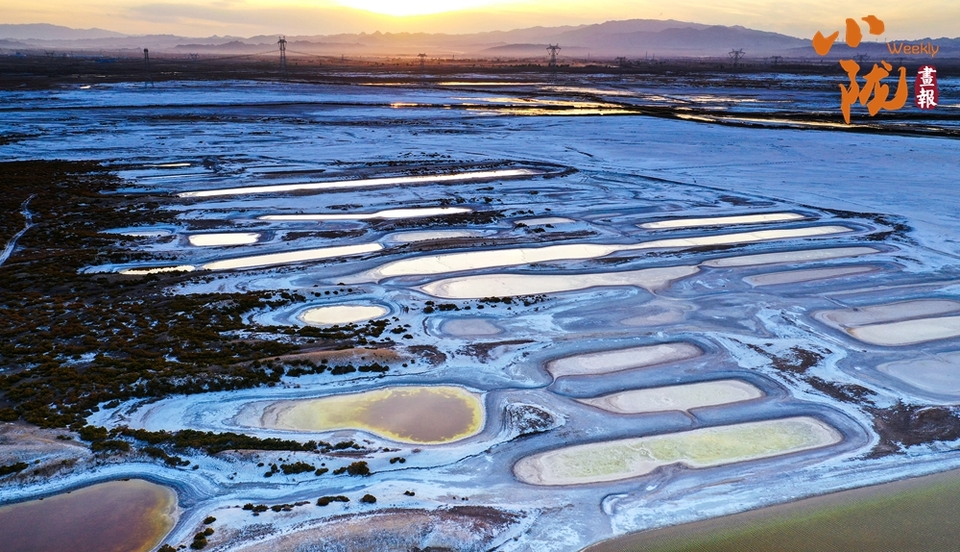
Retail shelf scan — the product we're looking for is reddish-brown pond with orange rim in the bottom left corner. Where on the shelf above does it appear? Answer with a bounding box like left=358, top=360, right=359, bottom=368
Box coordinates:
left=0, top=479, right=177, bottom=552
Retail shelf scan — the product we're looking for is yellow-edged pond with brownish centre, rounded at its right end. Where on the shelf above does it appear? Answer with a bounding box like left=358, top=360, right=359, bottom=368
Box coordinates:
left=260, top=385, right=484, bottom=444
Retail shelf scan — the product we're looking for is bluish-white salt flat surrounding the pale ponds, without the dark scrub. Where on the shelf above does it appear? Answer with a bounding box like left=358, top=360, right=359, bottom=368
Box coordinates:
left=0, top=73, right=960, bottom=551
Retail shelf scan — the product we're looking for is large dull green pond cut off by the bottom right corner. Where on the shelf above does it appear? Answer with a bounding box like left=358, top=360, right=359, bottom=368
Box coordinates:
left=584, top=470, right=960, bottom=552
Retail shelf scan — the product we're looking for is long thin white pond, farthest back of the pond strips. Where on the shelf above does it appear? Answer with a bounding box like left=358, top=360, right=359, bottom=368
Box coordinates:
left=178, top=169, right=544, bottom=201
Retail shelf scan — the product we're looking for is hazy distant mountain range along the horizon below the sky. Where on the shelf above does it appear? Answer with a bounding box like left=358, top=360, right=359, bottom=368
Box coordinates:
left=0, top=19, right=960, bottom=59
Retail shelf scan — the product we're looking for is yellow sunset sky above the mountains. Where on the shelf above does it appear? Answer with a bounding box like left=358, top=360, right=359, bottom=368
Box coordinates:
left=0, top=0, right=960, bottom=39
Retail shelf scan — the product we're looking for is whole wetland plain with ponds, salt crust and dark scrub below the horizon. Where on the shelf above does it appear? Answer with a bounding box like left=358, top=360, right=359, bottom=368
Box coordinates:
left=0, top=60, right=960, bottom=552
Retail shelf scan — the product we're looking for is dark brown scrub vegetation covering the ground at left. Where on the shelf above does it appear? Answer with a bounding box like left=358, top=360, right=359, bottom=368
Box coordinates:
left=0, top=161, right=402, bottom=429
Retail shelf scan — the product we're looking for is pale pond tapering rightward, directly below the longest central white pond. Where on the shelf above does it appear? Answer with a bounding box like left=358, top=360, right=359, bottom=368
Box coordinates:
left=420, top=266, right=700, bottom=299
